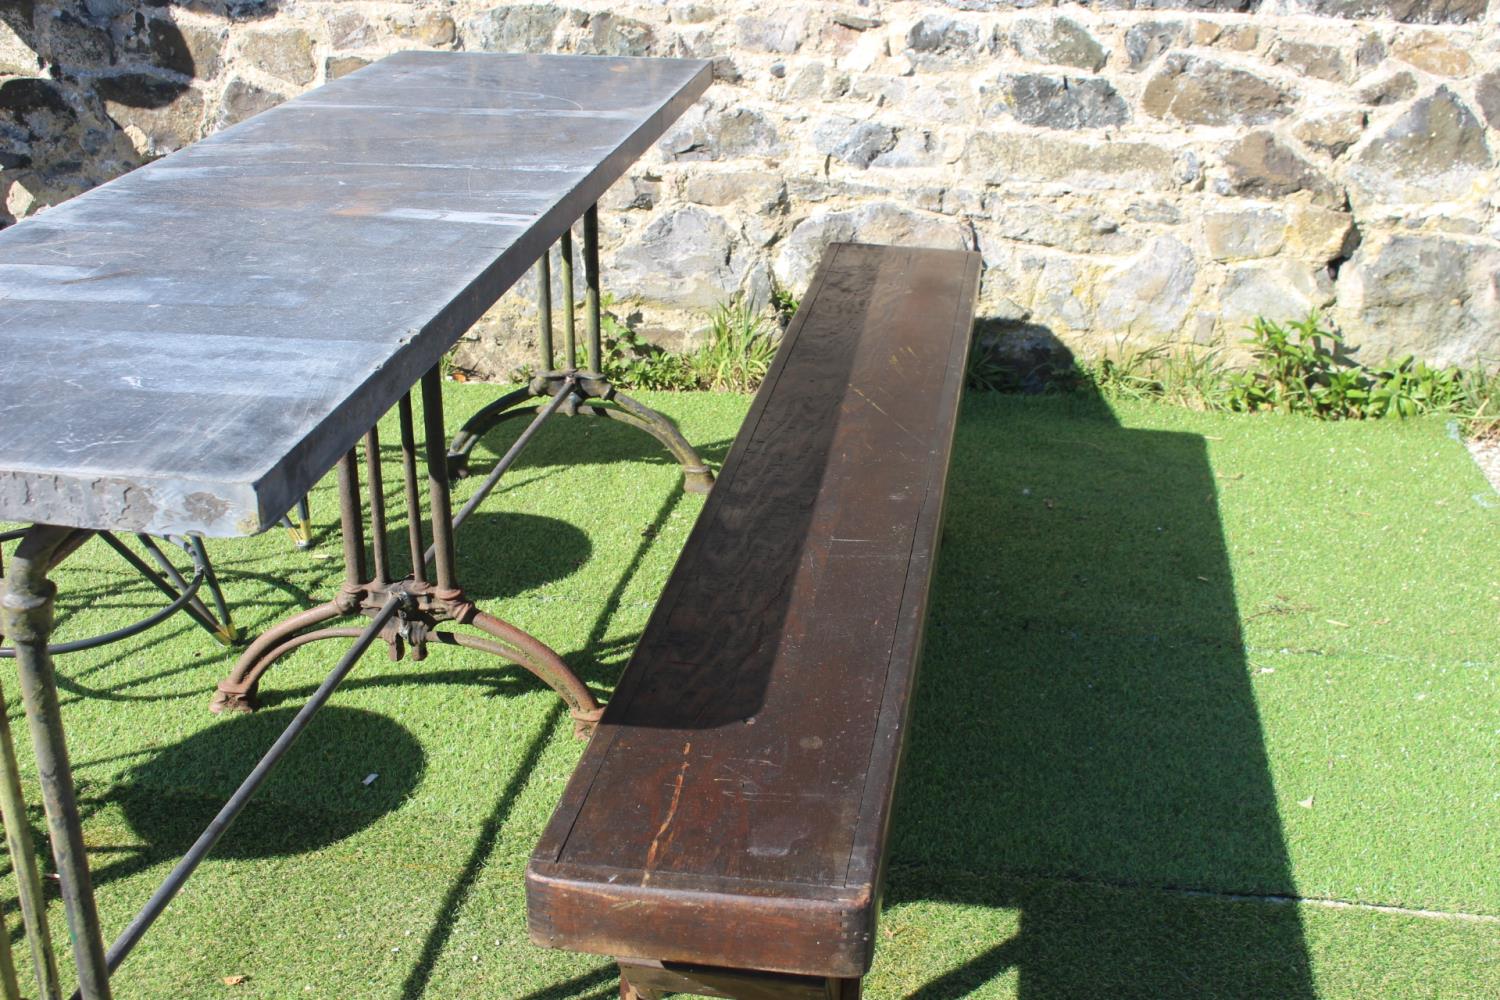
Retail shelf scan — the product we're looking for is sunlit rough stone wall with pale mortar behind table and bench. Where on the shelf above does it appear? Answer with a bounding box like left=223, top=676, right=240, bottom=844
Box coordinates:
left=0, top=0, right=1500, bottom=370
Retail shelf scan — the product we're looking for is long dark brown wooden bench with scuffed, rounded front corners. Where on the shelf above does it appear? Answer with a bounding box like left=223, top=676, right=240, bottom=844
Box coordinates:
left=527, top=243, right=980, bottom=1000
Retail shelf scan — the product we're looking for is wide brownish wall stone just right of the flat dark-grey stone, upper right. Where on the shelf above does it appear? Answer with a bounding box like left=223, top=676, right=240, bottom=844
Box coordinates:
left=1142, top=52, right=1295, bottom=124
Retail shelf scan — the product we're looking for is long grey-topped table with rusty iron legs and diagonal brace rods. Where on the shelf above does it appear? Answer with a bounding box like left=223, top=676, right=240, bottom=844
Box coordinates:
left=0, top=52, right=711, bottom=999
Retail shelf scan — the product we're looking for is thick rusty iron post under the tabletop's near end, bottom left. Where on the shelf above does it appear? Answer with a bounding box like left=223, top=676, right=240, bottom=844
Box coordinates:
left=0, top=525, right=110, bottom=1000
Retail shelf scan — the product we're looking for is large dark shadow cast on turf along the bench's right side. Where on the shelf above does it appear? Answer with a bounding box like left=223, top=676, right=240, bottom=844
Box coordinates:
left=887, top=365, right=1314, bottom=1000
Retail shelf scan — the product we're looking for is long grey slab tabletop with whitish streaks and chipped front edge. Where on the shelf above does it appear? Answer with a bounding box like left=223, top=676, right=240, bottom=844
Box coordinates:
left=0, top=52, right=711, bottom=535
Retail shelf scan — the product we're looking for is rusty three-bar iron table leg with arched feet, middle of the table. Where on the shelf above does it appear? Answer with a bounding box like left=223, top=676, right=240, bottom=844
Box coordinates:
left=210, top=369, right=602, bottom=738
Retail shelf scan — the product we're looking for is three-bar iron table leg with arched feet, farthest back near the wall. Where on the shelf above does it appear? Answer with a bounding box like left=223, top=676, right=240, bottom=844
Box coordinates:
left=447, top=205, right=714, bottom=493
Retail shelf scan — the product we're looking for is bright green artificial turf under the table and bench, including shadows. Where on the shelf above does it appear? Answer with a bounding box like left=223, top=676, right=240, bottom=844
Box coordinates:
left=6, top=385, right=1500, bottom=1000
